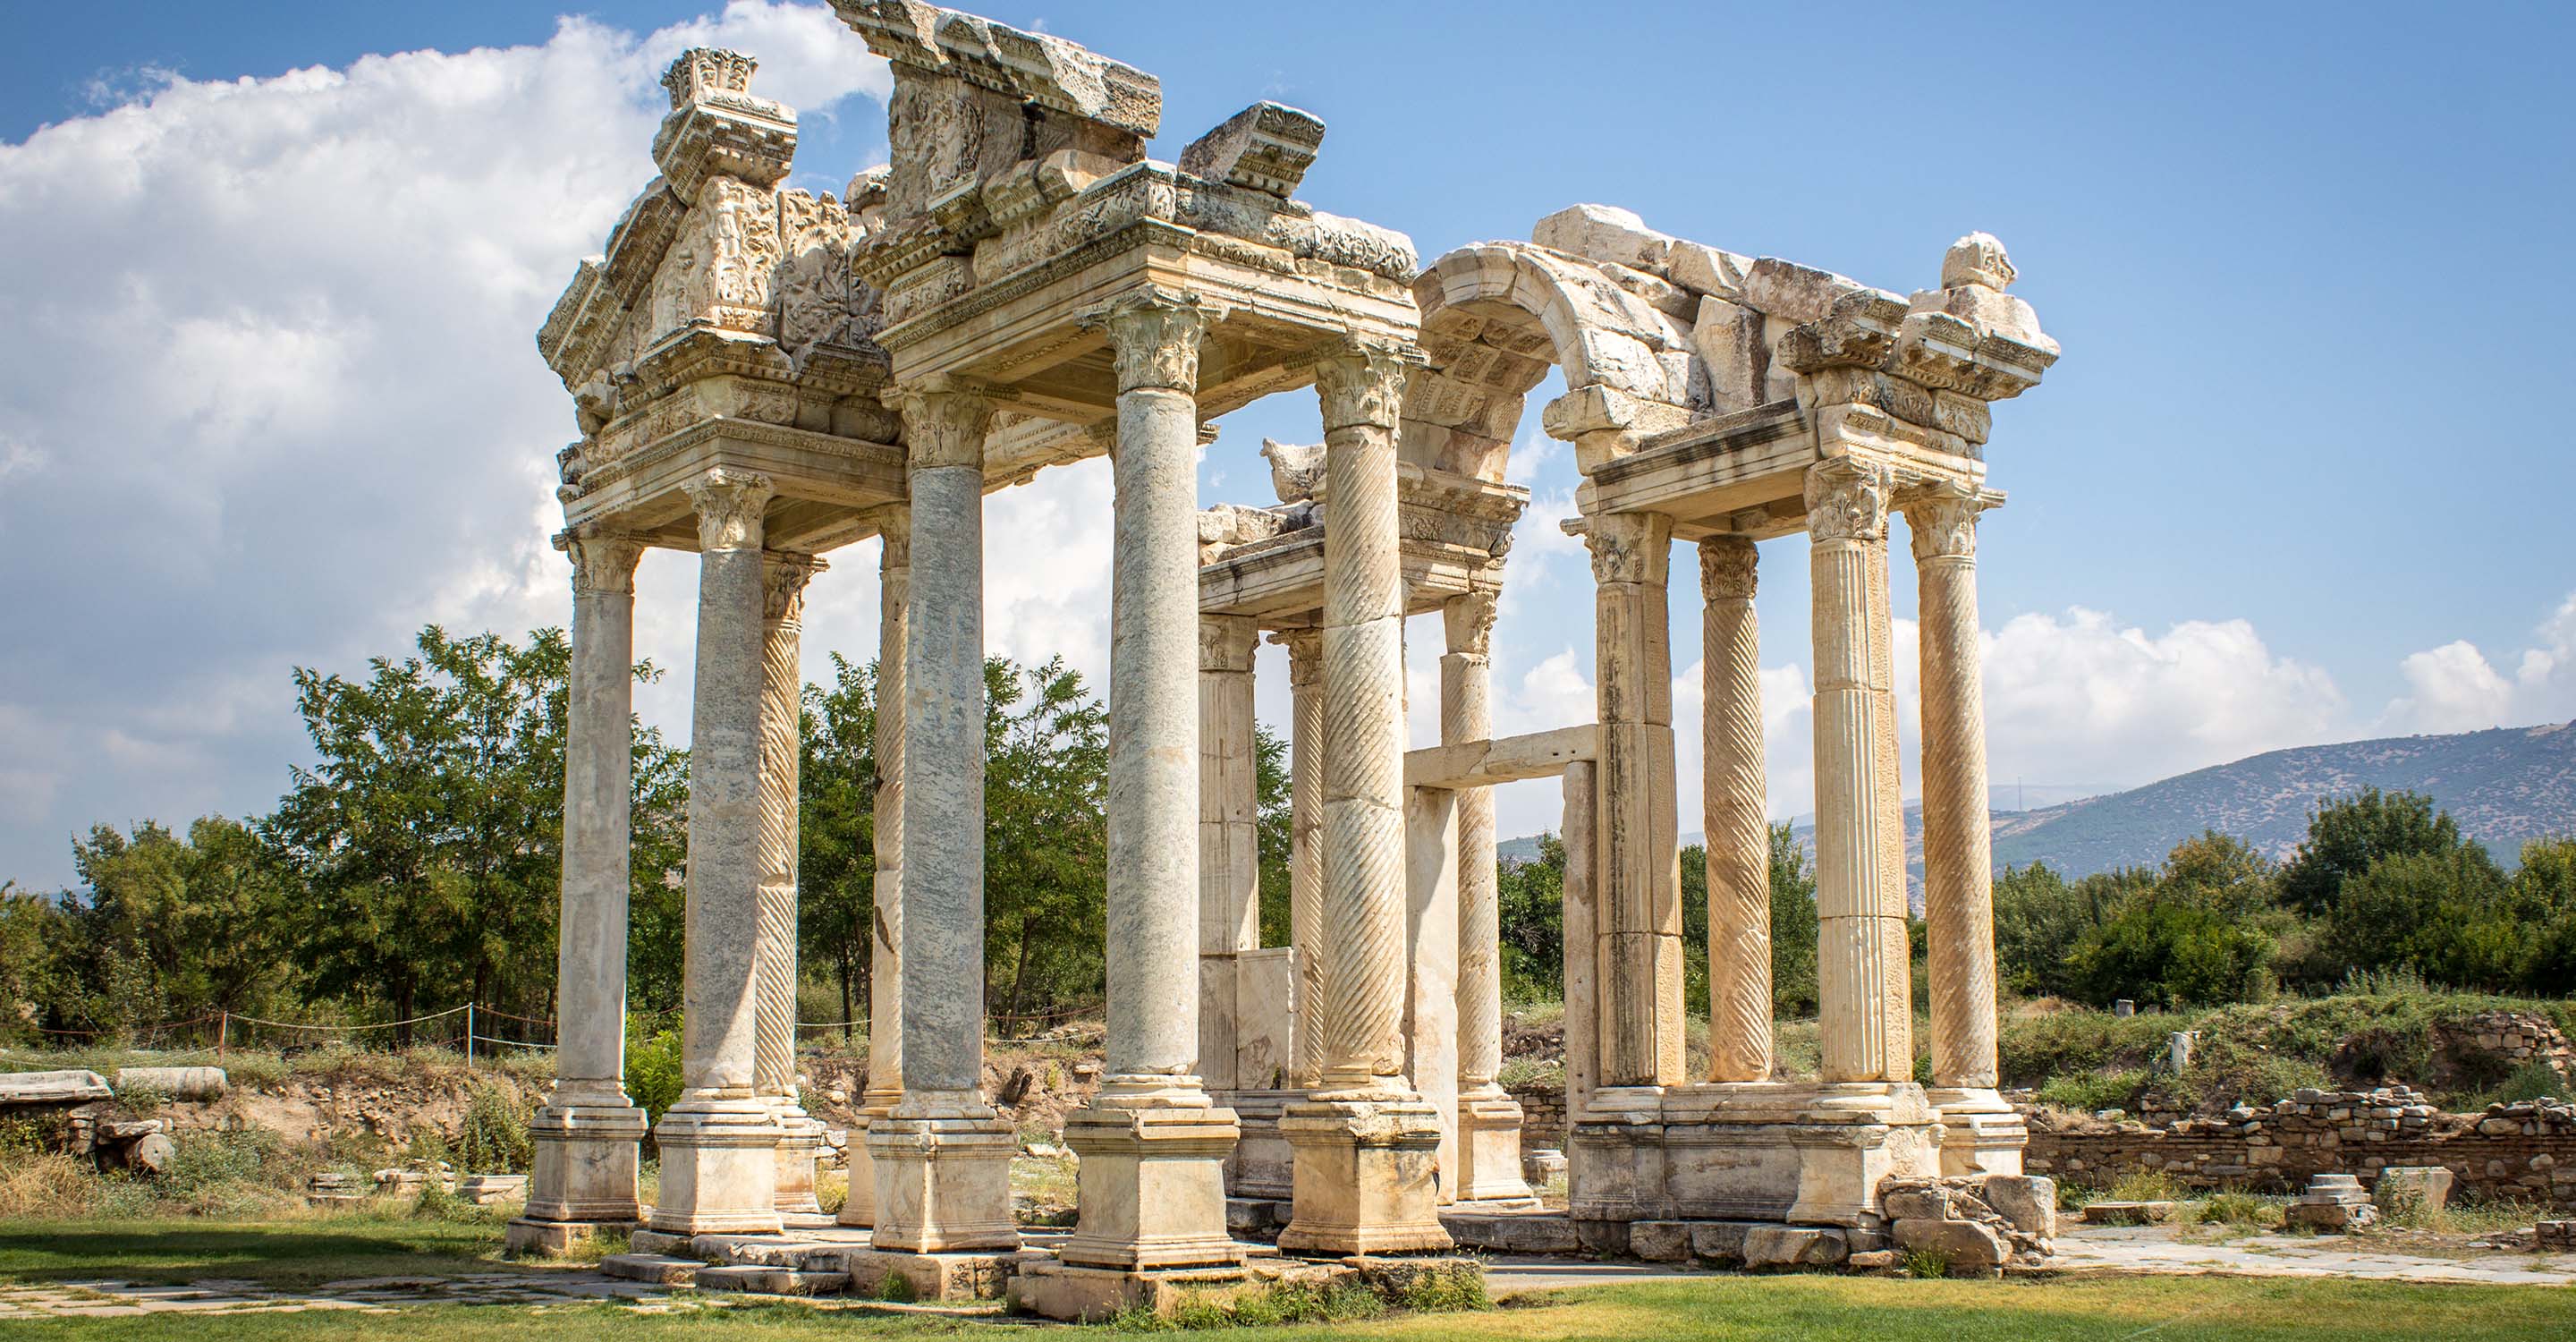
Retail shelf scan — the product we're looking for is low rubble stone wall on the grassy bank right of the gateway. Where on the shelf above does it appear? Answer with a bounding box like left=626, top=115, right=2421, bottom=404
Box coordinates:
left=2022, top=1087, right=2576, bottom=1205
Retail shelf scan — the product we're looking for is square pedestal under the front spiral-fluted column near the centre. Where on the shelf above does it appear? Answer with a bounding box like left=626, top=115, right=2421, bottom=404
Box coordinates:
left=1280, top=1092, right=1450, bottom=1257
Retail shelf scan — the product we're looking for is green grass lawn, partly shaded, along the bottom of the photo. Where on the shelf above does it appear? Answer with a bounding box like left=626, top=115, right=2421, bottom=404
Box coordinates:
left=0, top=1219, right=2576, bottom=1342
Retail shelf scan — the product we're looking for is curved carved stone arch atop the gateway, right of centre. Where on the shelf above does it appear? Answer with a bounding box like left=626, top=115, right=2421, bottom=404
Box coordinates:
left=1402, top=242, right=1690, bottom=480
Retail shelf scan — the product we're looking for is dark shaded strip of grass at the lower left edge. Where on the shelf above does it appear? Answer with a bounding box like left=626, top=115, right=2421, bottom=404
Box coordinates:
left=0, top=1221, right=500, bottom=1286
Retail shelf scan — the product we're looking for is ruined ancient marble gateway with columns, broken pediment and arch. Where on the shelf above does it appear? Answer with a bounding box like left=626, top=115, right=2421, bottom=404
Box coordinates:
left=513, top=0, right=2055, bottom=1313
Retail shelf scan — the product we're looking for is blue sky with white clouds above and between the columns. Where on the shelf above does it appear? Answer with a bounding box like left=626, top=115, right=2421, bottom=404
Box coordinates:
left=0, top=3, right=2576, bottom=886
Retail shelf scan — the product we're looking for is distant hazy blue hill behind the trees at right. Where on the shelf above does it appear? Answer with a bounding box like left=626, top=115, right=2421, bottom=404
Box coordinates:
left=1496, top=721, right=2576, bottom=891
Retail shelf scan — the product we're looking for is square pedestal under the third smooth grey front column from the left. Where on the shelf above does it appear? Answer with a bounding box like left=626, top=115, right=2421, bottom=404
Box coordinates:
left=869, top=1097, right=1020, bottom=1254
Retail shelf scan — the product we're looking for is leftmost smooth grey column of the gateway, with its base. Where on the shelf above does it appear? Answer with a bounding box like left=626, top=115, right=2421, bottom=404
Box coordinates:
left=510, top=533, right=644, bottom=1249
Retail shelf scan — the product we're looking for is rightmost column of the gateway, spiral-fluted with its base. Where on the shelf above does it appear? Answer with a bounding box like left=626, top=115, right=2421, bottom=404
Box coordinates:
left=1906, top=484, right=2025, bottom=1175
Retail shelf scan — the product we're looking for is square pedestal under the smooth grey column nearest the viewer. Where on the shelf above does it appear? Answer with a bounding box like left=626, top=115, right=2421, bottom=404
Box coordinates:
left=1056, top=1076, right=1244, bottom=1272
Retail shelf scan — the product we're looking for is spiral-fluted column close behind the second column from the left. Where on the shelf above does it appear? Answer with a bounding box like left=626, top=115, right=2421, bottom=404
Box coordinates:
left=752, top=551, right=825, bottom=1216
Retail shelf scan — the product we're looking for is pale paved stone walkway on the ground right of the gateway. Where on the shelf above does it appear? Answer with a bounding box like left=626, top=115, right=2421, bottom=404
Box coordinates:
left=2050, top=1226, right=2576, bottom=1286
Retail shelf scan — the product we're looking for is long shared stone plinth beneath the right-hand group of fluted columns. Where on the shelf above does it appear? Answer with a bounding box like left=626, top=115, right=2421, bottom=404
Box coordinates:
left=1569, top=1082, right=1943, bottom=1249
